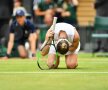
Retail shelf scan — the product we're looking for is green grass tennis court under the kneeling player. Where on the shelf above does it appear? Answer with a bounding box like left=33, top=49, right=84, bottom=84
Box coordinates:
left=0, top=53, right=108, bottom=90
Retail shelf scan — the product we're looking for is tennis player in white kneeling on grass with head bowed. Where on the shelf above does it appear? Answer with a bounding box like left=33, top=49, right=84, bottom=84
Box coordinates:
left=41, top=23, right=80, bottom=69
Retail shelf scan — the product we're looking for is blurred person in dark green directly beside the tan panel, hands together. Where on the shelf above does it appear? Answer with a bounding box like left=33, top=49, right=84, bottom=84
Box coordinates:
left=57, top=0, right=78, bottom=25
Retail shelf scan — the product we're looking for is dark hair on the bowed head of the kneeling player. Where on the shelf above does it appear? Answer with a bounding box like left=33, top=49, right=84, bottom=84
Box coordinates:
left=57, top=40, right=69, bottom=54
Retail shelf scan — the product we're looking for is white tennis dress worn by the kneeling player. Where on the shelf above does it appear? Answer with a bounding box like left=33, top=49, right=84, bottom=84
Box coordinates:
left=49, top=23, right=80, bottom=55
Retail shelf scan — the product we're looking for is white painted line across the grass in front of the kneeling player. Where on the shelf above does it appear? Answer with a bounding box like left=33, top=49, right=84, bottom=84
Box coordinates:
left=0, top=72, right=108, bottom=74
